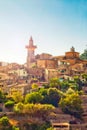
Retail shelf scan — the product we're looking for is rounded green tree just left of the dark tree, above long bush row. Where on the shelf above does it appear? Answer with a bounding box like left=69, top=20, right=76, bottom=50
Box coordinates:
left=25, top=92, right=43, bottom=103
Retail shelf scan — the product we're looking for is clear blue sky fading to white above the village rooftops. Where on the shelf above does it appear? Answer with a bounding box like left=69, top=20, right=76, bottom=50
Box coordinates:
left=0, top=0, right=87, bottom=63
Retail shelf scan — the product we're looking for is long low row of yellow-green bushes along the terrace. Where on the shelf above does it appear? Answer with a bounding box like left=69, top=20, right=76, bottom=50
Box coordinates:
left=14, top=103, right=54, bottom=117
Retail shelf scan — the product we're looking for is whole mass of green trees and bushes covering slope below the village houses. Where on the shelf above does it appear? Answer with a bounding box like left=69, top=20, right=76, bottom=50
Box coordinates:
left=0, top=74, right=87, bottom=130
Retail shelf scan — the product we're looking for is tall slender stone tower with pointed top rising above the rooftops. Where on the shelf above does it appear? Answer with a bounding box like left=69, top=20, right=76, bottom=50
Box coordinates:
left=26, top=37, right=37, bottom=68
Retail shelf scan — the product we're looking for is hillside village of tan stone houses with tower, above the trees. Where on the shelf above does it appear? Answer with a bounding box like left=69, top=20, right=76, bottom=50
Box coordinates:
left=0, top=37, right=87, bottom=94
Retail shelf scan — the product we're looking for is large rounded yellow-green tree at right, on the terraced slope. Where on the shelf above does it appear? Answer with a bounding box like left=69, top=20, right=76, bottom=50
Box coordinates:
left=59, top=92, right=83, bottom=117
